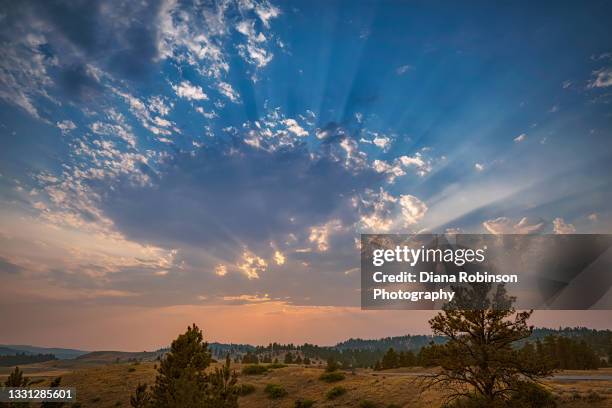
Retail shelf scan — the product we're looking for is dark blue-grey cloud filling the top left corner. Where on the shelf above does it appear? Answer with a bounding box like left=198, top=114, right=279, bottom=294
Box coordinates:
left=0, top=0, right=160, bottom=83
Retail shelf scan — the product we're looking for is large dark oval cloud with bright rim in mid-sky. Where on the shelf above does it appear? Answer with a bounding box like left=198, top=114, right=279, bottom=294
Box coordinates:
left=97, top=145, right=380, bottom=252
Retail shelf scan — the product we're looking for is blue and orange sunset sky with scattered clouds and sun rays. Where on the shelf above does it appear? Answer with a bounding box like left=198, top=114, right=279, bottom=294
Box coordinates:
left=0, top=0, right=612, bottom=350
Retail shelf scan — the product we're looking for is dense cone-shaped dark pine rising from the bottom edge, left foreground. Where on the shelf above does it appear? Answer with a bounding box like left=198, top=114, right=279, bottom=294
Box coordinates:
left=130, top=324, right=238, bottom=408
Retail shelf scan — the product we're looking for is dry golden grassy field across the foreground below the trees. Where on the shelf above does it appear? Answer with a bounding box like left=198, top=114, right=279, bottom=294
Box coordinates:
left=0, top=360, right=612, bottom=408
